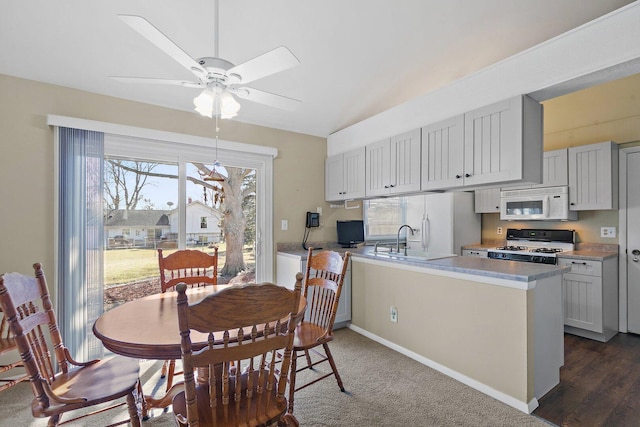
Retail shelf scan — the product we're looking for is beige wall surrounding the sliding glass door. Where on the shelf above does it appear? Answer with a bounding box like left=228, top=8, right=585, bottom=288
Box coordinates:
left=0, top=75, right=361, bottom=280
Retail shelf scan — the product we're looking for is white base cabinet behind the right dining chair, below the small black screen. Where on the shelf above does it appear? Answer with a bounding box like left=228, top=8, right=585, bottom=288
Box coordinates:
left=276, top=252, right=351, bottom=329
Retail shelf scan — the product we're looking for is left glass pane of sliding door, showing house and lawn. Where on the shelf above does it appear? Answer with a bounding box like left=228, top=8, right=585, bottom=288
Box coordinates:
left=104, top=157, right=178, bottom=310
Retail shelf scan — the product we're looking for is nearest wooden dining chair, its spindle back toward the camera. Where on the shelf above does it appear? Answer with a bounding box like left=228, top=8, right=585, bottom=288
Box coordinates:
left=173, top=274, right=302, bottom=427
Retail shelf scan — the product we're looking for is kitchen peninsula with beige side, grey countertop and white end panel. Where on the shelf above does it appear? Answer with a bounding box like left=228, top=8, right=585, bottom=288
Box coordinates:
left=332, top=248, right=567, bottom=413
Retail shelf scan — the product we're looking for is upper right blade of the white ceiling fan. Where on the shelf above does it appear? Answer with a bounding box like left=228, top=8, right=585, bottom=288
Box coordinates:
left=227, top=46, right=300, bottom=84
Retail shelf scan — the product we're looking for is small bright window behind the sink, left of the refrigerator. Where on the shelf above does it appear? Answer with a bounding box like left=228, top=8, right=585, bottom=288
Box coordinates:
left=364, top=197, right=406, bottom=240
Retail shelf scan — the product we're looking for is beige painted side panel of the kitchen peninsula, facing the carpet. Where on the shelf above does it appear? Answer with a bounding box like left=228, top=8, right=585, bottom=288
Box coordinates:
left=351, top=258, right=534, bottom=403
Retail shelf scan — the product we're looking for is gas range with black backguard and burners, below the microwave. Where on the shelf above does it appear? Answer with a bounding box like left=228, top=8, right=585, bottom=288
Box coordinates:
left=487, top=228, right=575, bottom=265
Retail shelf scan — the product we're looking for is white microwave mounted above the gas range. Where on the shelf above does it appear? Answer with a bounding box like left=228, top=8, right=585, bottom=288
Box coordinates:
left=500, top=186, right=578, bottom=221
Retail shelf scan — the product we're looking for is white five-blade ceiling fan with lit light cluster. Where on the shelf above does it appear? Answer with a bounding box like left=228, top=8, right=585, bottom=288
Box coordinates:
left=111, top=0, right=300, bottom=119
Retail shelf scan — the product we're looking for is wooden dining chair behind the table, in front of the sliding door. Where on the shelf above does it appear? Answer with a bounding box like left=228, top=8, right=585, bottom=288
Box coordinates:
left=158, top=246, right=218, bottom=391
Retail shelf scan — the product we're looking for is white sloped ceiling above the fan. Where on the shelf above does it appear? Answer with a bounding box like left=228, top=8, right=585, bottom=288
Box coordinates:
left=0, top=0, right=632, bottom=137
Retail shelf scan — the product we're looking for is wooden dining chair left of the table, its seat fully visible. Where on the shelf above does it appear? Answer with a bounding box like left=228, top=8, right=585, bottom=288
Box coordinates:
left=0, top=264, right=142, bottom=427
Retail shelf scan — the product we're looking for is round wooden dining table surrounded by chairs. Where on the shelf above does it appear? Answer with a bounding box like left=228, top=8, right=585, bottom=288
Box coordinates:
left=93, top=285, right=306, bottom=408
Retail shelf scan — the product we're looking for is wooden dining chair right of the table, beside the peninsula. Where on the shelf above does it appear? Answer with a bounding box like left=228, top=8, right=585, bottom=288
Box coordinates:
left=289, top=248, right=351, bottom=414
